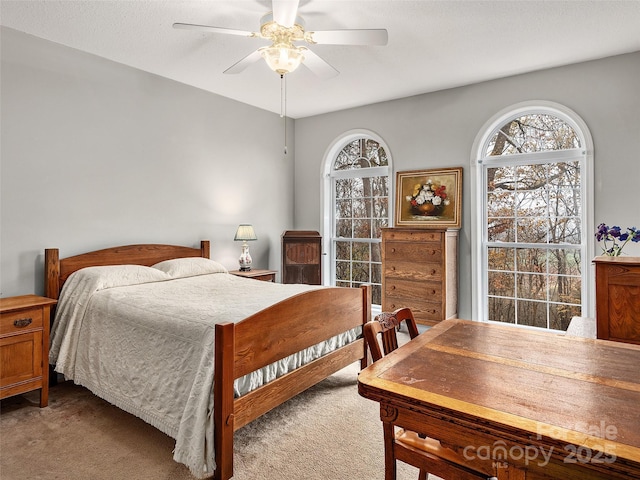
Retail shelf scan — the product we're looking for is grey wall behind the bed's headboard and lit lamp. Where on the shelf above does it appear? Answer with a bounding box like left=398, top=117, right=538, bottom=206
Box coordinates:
left=0, top=28, right=294, bottom=297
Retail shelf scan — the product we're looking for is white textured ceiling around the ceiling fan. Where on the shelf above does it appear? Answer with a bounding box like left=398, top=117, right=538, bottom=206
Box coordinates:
left=0, top=0, right=640, bottom=118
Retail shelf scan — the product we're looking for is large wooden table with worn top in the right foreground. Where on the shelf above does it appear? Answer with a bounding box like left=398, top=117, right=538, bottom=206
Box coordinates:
left=358, top=320, right=640, bottom=480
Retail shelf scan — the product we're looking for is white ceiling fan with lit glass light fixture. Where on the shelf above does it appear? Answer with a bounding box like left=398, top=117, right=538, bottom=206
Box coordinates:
left=173, top=0, right=388, bottom=78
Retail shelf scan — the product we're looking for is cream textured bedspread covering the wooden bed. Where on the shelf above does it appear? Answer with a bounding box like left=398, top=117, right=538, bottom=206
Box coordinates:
left=49, top=266, right=356, bottom=478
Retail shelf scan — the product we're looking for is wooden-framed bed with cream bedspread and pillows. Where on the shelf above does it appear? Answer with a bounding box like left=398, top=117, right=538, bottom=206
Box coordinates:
left=45, top=240, right=371, bottom=480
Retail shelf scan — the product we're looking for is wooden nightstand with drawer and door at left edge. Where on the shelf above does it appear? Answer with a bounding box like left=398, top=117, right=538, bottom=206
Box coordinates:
left=0, top=295, right=56, bottom=407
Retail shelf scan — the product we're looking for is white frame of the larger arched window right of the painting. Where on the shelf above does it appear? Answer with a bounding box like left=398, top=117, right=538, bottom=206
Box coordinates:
left=470, top=100, right=595, bottom=328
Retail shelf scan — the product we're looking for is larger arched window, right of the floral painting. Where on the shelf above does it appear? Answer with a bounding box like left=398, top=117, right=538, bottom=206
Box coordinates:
left=472, top=102, right=593, bottom=330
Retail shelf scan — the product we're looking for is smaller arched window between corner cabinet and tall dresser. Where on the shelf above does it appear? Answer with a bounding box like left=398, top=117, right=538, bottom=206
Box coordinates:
left=323, top=132, right=391, bottom=305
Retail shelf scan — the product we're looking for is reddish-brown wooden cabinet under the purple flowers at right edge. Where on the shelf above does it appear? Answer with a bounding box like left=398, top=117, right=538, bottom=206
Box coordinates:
left=593, top=256, right=640, bottom=344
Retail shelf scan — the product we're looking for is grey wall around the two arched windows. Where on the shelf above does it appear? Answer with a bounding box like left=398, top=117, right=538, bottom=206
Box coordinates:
left=294, top=52, right=640, bottom=318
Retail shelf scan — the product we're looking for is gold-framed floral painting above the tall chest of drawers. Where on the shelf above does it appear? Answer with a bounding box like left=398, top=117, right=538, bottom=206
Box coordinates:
left=395, top=167, right=462, bottom=228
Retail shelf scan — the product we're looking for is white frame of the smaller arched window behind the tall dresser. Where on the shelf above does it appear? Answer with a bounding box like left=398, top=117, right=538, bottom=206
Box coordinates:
left=320, top=129, right=395, bottom=313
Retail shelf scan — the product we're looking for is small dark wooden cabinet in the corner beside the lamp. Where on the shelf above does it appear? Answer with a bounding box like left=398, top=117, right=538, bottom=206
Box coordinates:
left=282, top=230, right=322, bottom=285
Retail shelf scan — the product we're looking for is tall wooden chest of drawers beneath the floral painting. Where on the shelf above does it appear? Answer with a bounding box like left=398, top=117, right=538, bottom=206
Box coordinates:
left=382, top=228, right=458, bottom=325
